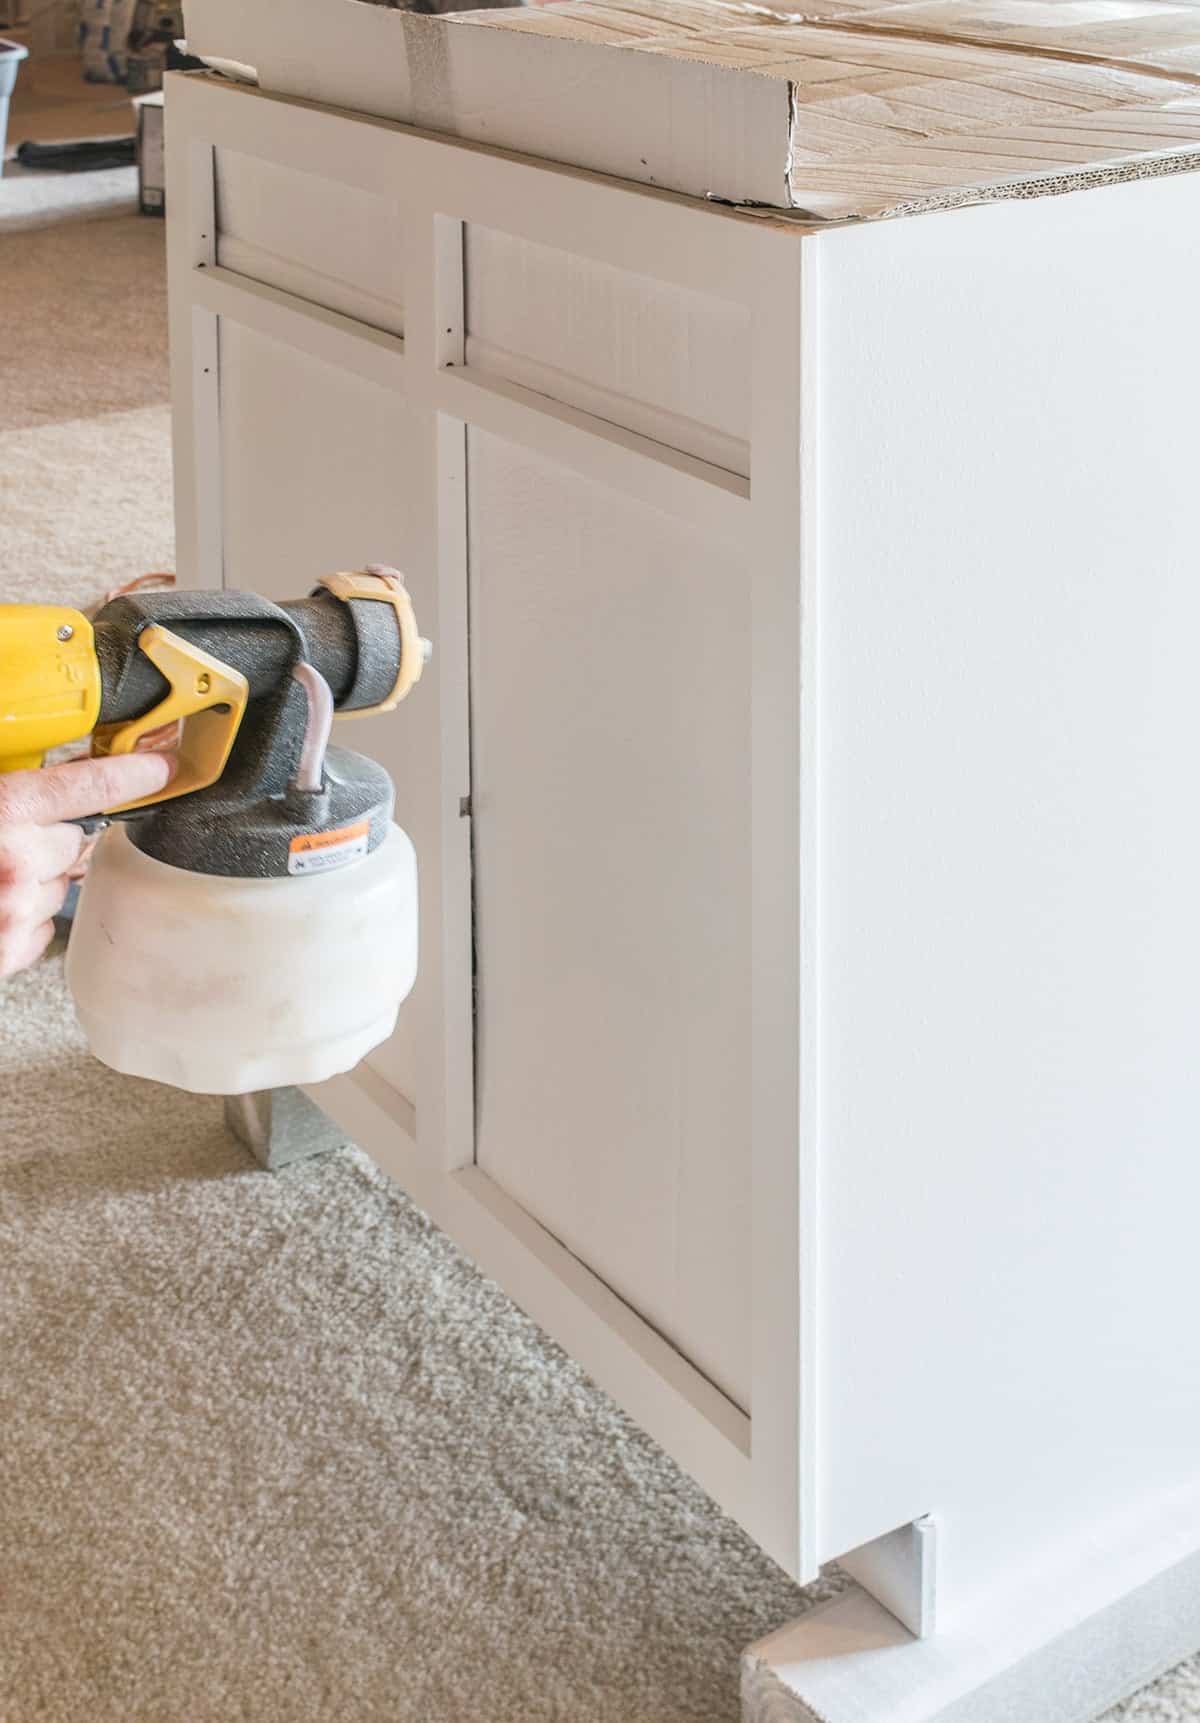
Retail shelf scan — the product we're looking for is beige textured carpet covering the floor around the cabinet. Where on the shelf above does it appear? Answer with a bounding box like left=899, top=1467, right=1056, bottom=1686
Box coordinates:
left=0, top=185, right=1200, bottom=1723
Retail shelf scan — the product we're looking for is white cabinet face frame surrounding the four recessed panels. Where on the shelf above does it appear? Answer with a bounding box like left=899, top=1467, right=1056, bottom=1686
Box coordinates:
left=166, top=74, right=824, bottom=1580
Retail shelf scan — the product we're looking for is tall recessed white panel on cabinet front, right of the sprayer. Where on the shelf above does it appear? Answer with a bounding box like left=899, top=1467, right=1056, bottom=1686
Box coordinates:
left=467, top=432, right=750, bottom=1408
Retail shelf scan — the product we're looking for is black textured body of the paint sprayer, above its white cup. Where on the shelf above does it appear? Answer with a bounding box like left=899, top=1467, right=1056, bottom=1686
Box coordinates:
left=95, top=570, right=418, bottom=879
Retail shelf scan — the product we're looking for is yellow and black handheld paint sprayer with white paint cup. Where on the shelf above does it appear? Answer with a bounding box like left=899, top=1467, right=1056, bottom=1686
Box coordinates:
left=0, top=567, right=429, bottom=1094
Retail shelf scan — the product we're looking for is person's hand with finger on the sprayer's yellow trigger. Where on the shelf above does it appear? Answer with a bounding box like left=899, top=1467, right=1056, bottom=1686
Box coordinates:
left=0, top=753, right=174, bottom=979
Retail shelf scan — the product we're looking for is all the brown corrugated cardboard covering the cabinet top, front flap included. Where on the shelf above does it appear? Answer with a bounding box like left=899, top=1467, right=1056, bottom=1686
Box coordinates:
left=186, top=0, right=1200, bottom=221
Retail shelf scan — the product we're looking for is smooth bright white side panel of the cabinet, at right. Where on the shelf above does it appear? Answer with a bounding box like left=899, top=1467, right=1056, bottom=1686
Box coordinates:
left=820, top=174, right=1200, bottom=1605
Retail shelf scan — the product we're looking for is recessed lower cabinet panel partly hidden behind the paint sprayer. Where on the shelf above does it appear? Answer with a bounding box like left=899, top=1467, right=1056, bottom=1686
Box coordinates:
left=221, top=317, right=429, bottom=1104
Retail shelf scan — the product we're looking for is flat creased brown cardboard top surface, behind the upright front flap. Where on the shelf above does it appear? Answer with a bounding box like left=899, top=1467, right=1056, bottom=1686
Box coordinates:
left=443, top=0, right=1200, bottom=221
